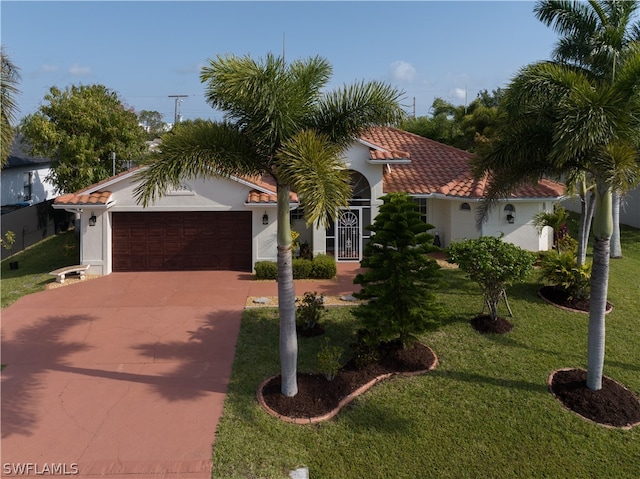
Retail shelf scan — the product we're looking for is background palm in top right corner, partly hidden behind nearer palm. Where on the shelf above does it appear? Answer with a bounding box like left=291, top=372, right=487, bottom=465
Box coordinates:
left=534, top=0, right=640, bottom=262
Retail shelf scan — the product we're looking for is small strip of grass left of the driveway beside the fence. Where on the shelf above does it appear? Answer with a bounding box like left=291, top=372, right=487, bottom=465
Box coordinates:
left=0, top=231, right=80, bottom=308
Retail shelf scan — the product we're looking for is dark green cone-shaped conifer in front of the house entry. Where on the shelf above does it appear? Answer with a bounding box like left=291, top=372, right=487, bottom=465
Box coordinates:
left=353, top=193, right=442, bottom=354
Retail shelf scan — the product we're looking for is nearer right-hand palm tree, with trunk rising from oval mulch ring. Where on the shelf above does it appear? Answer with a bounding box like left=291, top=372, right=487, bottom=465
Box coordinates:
left=475, top=45, right=640, bottom=390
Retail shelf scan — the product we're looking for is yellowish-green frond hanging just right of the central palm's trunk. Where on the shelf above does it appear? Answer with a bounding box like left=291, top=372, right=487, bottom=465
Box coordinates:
left=277, top=130, right=352, bottom=226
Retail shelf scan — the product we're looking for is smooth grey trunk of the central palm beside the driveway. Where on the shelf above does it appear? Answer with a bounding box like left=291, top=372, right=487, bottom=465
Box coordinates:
left=278, top=185, right=298, bottom=397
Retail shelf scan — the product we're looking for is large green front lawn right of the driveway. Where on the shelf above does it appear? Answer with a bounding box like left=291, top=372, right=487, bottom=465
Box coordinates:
left=213, top=228, right=640, bottom=479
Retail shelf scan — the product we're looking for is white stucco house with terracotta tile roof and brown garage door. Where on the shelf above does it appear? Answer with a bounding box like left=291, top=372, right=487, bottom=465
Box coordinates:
left=54, top=128, right=564, bottom=274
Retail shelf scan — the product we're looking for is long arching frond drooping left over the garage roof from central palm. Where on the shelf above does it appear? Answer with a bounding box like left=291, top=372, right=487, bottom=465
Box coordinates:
left=134, top=120, right=269, bottom=206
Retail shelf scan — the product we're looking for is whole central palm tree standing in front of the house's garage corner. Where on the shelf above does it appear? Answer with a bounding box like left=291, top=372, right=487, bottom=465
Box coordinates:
left=136, top=54, right=403, bottom=396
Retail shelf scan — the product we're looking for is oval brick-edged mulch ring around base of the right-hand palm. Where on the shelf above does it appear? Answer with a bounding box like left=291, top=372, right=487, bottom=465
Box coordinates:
left=548, top=369, right=640, bottom=429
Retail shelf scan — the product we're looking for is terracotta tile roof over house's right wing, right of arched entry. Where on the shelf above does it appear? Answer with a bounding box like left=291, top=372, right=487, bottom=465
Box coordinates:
left=361, top=127, right=564, bottom=198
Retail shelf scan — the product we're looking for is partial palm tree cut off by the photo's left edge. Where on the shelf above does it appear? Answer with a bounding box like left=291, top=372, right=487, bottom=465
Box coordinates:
left=0, top=47, right=20, bottom=166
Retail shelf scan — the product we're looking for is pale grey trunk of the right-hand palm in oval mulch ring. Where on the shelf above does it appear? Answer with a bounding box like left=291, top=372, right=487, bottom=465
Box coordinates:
left=587, top=184, right=613, bottom=391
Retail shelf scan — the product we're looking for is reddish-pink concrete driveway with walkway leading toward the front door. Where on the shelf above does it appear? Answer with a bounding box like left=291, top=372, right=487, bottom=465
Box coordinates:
left=0, top=264, right=357, bottom=479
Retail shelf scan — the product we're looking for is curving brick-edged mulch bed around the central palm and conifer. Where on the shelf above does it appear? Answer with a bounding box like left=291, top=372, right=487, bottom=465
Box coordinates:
left=257, top=343, right=438, bottom=424
